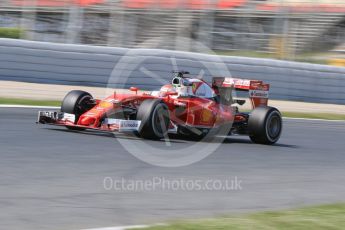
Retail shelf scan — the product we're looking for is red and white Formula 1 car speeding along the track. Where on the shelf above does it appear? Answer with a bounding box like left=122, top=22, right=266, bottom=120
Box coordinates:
left=38, top=71, right=282, bottom=144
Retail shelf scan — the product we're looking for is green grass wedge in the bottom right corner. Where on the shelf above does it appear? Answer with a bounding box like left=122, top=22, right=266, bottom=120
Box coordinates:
left=134, top=204, right=345, bottom=230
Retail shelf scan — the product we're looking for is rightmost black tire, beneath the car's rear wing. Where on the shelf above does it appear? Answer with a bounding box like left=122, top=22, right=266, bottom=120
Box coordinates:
left=248, top=107, right=283, bottom=145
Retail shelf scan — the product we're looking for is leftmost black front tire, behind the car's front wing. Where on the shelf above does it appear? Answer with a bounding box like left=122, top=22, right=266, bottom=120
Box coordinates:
left=61, top=90, right=93, bottom=130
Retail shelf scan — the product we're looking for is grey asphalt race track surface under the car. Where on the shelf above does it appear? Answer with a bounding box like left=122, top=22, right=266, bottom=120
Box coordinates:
left=0, top=108, right=345, bottom=230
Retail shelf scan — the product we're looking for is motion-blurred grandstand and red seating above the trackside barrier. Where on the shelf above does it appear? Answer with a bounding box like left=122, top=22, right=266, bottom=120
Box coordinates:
left=0, top=0, right=345, bottom=66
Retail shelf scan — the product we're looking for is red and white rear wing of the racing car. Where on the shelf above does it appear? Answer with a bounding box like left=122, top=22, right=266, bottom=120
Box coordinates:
left=212, top=77, right=270, bottom=108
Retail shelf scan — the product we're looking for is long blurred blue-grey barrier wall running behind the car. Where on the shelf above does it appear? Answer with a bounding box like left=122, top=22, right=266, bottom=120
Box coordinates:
left=0, top=39, right=345, bottom=104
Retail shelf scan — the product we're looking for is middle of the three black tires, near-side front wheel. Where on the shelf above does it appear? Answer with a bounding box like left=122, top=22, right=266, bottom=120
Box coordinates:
left=137, top=99, right=170, bottom=140
